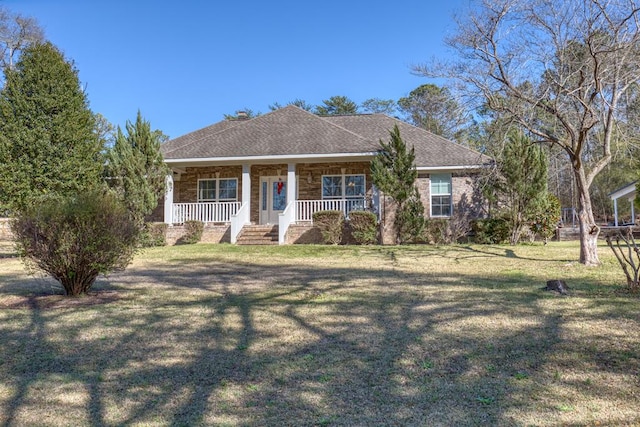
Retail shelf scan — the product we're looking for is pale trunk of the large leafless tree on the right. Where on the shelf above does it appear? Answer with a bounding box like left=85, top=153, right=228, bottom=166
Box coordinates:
left=574, top=169, right=600, bottom=266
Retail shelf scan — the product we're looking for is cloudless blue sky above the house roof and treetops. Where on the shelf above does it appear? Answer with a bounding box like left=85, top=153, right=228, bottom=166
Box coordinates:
left=0, top=0, right=466, bottom=138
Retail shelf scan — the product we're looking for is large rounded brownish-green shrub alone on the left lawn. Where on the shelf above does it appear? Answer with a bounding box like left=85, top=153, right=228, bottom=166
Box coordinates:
left=11, top=192, right=140, bottom=296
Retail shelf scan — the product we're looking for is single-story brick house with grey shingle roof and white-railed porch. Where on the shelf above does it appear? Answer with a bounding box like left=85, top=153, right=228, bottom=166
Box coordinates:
left=162, top=106, right=489, bottom=244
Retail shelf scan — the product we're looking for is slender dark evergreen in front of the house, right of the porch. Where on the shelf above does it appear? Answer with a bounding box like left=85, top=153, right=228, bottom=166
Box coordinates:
left=371, top=126, right=424, bottom=243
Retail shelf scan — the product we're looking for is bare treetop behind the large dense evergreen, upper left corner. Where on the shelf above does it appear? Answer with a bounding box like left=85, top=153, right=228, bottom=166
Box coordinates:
left=0, top=7, right=44, bottom=69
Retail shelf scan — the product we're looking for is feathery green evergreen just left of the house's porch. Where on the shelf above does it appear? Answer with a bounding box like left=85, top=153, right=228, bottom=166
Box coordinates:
left=106, top=111, right=169, bottom=222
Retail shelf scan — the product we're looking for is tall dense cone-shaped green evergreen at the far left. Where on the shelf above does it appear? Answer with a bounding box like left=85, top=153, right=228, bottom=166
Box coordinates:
left=0, top=42, right=103, bottom=211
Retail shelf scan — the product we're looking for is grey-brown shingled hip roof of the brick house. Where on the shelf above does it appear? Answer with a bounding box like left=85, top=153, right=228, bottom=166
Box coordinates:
left=161, top=106, right=489, bottom=167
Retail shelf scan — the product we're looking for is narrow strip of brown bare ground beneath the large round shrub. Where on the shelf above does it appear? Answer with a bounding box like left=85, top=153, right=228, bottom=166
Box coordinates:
left=0, top=291, right=122, bottom=310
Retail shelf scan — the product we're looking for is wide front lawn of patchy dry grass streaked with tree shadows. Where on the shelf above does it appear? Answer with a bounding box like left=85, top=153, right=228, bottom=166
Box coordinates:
left=0, top=243, right=640, bottom=426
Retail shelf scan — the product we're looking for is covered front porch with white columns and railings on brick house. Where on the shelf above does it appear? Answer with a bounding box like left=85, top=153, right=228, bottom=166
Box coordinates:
left=164, top=161, right=378, bottom=244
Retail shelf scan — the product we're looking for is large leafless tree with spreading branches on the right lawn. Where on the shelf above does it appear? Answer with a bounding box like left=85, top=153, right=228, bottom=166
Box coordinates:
left=415, top=0, right=640, bottom=265
